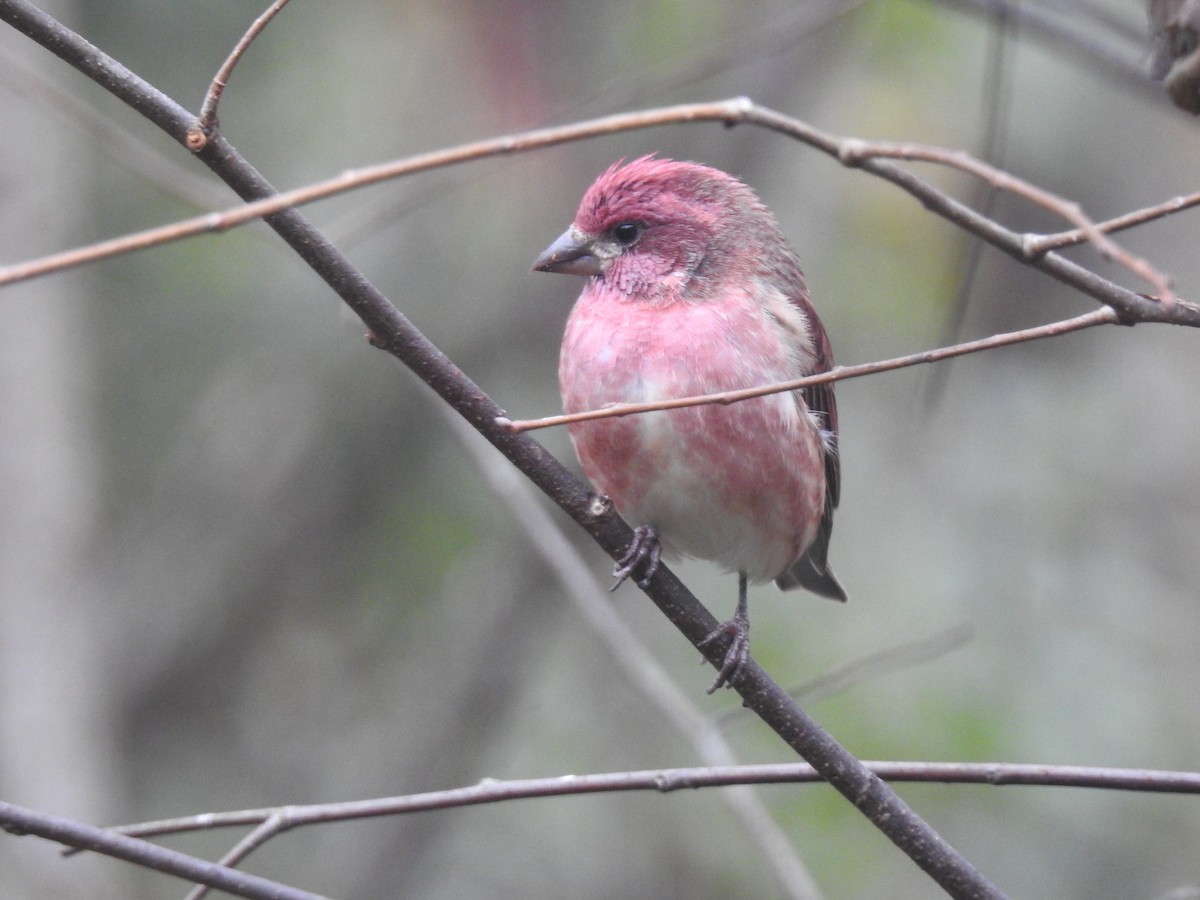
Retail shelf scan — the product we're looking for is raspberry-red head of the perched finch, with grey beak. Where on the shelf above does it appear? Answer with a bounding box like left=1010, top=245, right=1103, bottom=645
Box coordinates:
left=533, top=156, right=790, bottom=302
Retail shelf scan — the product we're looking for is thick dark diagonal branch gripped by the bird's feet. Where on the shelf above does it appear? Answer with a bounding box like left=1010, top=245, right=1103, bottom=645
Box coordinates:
left=0, top=0, right=1003, bottom=898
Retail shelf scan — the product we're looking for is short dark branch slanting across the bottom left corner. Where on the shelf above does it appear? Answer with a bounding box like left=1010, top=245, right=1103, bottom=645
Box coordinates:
left=0, top=800, right=323, bottom=900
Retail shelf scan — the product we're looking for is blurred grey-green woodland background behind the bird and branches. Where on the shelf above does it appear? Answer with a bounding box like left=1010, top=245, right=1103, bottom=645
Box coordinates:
left=0, top=0, right=1200, bottom=900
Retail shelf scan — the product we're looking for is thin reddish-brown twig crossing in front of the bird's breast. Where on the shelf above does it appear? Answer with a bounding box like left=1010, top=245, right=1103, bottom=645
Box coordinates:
left=498, top=306, right=1121, bottom=434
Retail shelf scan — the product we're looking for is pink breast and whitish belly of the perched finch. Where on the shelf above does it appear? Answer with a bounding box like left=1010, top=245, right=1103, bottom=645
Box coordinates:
left=559, top=287, right=824, bottom=581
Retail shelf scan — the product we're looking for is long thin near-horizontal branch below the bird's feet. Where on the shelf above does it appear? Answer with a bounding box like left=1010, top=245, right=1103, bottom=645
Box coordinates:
left=96, top=761, right=1200, bottom=838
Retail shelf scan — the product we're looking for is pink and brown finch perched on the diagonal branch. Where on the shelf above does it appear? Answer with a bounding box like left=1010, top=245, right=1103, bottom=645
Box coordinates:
left=533, top=156, right=846, bottom=692
